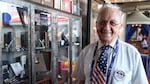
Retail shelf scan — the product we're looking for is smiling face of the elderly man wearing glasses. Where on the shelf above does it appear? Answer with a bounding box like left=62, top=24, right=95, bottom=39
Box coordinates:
left=96, top=8, right=122, bottom=43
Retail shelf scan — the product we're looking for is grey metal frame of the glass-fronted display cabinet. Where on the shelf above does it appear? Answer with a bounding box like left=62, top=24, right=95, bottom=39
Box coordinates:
left=0, top=0, right=82, bottom=84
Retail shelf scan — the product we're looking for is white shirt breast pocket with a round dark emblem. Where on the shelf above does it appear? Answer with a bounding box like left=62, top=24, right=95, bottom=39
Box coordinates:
left=110, top=70, right=132, bottom=84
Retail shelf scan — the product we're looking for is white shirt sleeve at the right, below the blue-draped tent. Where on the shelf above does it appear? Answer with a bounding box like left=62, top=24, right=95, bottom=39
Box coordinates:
left=132, top=54, right=148, bottom=84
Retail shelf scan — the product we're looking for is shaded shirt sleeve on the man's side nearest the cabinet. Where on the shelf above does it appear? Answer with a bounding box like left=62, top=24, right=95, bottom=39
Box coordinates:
left=72, top=51, right=85, bottom=80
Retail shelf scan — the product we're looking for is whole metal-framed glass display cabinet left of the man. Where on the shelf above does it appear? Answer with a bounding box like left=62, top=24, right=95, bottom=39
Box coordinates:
left=0, top=0, right=82, bottom=84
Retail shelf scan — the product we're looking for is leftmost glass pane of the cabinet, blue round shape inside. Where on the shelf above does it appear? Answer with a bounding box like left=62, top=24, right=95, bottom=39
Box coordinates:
left=0, top=1, right=30, bottom=84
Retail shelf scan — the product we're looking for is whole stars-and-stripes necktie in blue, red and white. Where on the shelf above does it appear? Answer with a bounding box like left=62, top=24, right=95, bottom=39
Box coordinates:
left=92, top=46, right=109, bottom=84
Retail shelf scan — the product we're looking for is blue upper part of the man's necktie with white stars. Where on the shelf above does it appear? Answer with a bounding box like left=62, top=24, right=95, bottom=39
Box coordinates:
left=97, top=46, right=110, bottom=75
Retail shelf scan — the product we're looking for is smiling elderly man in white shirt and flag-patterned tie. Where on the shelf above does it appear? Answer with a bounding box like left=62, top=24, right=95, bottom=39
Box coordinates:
left=72, top=4, right=148, bottom=84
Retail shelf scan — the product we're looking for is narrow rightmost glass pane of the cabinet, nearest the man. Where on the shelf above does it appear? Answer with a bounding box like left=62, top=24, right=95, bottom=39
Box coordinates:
left=71, top=18, right=82, bottom=71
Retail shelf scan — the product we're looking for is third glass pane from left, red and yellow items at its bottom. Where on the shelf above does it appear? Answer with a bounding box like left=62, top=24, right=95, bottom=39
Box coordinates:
left=57, top=15, right=71, bottom=83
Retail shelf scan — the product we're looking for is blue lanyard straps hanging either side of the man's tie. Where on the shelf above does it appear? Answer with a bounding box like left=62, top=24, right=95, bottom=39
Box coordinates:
left=90, top=40, right=119, bottom=84
